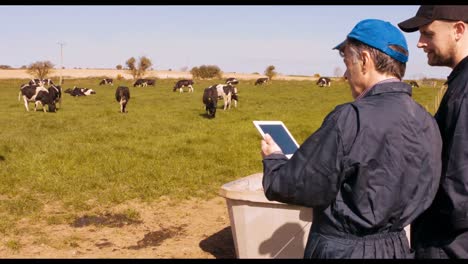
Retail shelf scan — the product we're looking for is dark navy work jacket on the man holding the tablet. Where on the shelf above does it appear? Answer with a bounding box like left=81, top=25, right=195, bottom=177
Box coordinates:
left=263, top=82, right=442, bottom=258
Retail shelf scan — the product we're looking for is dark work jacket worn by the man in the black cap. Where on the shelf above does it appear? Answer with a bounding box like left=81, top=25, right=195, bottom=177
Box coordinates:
left=412, top=57, right=468, bottom=258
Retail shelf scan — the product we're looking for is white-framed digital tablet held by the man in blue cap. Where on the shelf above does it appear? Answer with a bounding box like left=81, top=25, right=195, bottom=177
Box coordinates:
left=253, top=121, right=299, bottom=159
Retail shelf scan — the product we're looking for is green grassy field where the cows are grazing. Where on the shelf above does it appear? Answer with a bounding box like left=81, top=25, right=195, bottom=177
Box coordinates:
left=0, top=78, right=446, bottom=232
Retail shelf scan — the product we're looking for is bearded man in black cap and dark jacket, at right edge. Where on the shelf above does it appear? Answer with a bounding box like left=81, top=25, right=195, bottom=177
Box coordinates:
left=398, top=5, right=468, bottom=258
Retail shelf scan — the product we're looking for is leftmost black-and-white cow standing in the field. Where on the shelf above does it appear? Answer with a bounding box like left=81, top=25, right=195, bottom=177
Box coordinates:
left=20, top=85, right=57, bottom=112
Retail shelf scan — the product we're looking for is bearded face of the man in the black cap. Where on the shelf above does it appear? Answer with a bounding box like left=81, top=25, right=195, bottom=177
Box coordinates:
left=417, top=20, right=456, bottom=68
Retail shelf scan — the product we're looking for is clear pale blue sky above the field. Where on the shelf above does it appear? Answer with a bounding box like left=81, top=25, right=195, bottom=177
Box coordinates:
left=0, top=5, right=451, bottom=79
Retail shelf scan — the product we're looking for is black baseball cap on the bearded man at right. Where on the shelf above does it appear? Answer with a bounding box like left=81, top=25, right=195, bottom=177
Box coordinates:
left=398, top=5, right=468, bottom=32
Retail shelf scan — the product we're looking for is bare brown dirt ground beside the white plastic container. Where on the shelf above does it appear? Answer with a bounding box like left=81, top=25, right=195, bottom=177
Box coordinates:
left=0, top=197, right=235, bottom=259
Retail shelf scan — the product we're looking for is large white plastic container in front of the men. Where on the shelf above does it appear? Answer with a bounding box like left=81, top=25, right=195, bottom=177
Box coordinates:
left=219, top=173, right=410, bottom=258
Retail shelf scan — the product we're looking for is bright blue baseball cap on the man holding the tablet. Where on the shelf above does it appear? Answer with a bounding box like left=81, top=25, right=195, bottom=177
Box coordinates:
left=333, top=19, right=408, bottom=63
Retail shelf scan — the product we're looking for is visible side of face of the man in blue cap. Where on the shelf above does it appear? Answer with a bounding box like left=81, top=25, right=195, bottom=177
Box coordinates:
left=343, top=46, right=365, bottom=98
